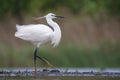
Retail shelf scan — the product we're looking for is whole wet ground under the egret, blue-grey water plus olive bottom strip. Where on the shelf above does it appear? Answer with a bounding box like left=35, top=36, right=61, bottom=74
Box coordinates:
left=0, top=68, right=120, bottom=80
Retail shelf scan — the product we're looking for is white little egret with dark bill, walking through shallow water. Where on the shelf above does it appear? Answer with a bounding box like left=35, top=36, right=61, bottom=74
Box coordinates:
left=15, top=13, right=63, bottom=74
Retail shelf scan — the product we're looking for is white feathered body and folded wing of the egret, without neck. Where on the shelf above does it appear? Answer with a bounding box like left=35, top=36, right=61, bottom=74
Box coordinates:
left=15, top=24, right=53, bottom=44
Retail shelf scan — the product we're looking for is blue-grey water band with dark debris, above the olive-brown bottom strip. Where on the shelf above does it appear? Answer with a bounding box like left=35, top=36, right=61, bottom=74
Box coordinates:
left=0, top=68, right=120, bottom=77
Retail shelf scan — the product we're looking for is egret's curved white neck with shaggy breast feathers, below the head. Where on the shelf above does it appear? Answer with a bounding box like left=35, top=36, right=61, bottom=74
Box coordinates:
left=46, top=18, right=61, bottom=46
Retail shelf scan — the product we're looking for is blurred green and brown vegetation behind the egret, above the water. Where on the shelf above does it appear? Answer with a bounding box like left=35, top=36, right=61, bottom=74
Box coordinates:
left=0, top=0, right=120, bottom=68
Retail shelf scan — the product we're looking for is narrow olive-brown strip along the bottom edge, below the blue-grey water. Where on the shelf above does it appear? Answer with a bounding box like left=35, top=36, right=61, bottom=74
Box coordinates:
left=0, top=76, right=120, bottom=80
